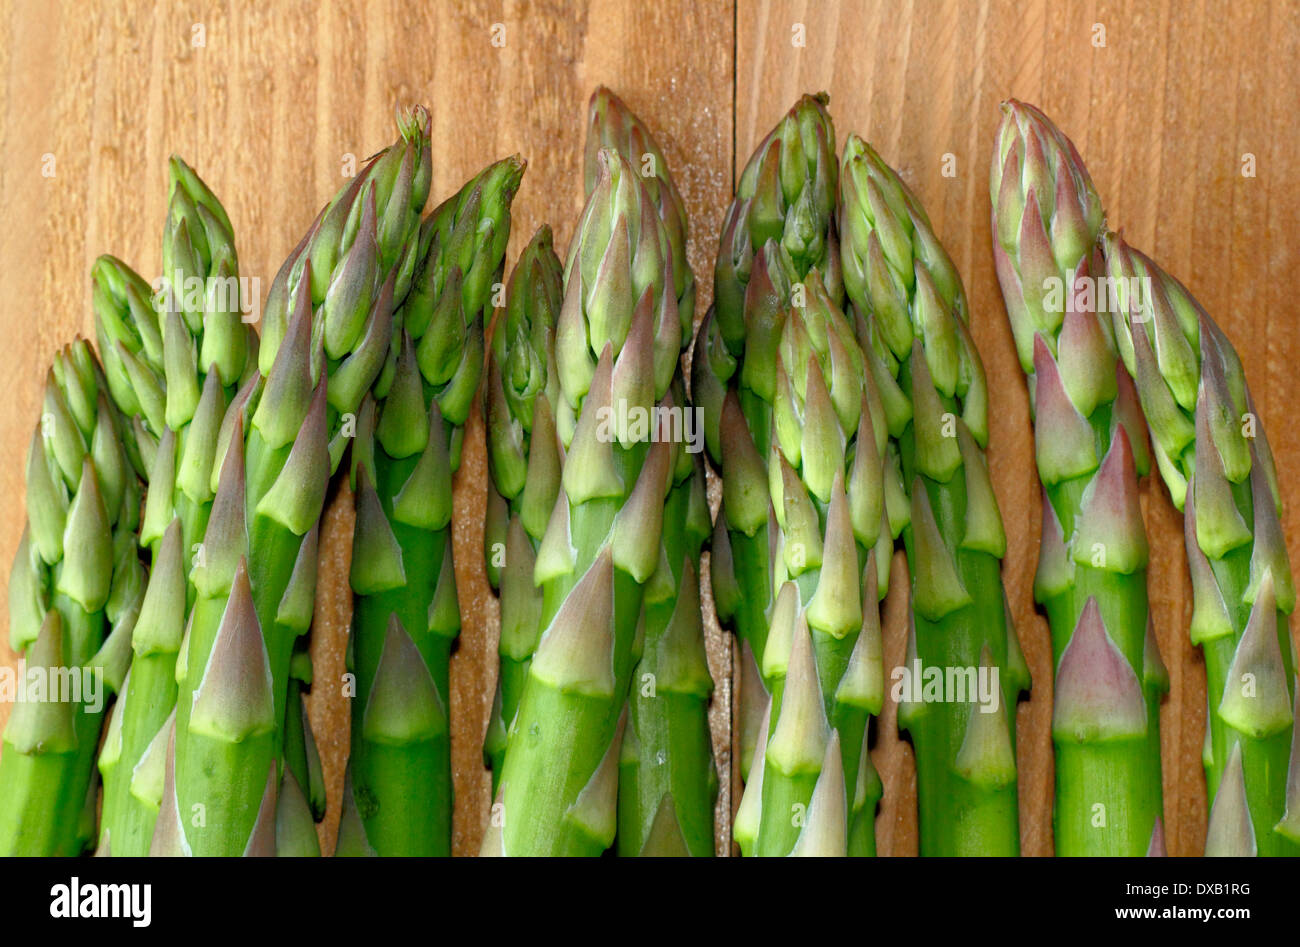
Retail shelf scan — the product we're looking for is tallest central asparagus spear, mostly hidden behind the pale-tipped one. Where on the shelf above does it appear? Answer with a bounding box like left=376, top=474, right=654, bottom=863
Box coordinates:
left=586, top=86, right=718, bottom=856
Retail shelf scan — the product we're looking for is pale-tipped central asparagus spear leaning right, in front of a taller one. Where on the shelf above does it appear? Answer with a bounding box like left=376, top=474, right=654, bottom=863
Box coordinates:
left=484, top=150, right=683, bottom=856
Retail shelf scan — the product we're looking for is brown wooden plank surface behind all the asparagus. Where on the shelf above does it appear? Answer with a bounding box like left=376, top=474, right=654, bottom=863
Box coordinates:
left=0, top=0, right=1300, bottom=855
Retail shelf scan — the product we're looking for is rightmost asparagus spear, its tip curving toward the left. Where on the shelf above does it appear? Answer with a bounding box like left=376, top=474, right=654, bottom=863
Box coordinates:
left=1102, top=233, right=1300, bottom=855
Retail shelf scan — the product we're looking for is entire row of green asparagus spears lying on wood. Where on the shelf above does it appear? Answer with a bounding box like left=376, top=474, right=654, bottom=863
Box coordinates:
left=0, top=87, right=1300, bottom=856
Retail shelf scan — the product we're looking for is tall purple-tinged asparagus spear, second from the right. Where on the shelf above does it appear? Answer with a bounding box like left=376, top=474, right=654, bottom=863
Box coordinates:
left=991, top=101, right=1169, bottom=855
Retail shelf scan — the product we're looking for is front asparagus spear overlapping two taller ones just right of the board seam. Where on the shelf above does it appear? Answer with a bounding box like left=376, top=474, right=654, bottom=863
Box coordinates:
left=723, top=267, right=893, bottom=856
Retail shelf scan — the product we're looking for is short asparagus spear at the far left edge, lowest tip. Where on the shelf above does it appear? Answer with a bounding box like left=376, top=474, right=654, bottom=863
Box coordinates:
left=0, top=340, right=144, bottom=855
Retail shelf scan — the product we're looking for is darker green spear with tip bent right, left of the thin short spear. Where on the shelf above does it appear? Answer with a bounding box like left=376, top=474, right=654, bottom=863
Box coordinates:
left=351, top=156, right=524, bottom=855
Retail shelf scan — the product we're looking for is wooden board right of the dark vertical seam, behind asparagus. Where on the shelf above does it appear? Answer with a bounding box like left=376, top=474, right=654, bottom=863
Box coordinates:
left=736, top=0, right=1300, bottom=855
